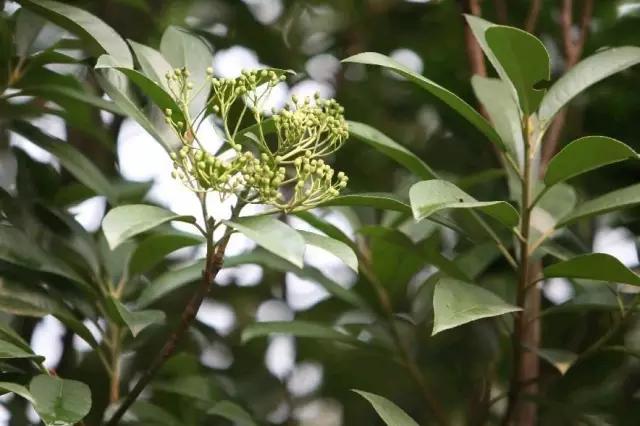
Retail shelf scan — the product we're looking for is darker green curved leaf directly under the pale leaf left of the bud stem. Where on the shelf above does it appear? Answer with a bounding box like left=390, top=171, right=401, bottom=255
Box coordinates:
left=129, top=231, right=205, bottom=274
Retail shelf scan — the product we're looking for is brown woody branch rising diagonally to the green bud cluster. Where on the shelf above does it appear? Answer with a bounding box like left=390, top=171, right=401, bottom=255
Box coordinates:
left=106, top=233, right=231, bottom=426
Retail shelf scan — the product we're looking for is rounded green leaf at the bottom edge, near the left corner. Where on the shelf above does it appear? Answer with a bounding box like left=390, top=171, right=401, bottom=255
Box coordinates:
left=29, top=374, right=91, bottom=426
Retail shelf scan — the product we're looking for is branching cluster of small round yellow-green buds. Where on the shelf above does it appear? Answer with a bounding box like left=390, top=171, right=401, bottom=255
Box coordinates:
left=165, top=68, right=349, bottom=212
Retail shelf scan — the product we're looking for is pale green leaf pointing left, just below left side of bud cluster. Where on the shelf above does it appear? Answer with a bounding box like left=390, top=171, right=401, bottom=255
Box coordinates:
left=102, top=204, right=195, bottom=250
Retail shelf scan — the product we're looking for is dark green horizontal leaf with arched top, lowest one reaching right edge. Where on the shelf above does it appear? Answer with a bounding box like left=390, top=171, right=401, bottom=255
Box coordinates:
left=544, top=253, right=640, bottom=285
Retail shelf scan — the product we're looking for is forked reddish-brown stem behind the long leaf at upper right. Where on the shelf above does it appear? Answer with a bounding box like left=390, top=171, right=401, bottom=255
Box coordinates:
left=540, top=0, right=594, bottom=174
